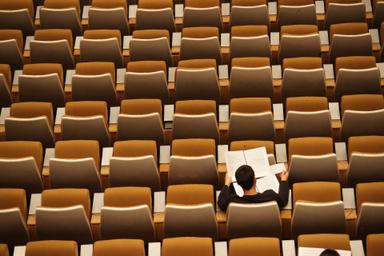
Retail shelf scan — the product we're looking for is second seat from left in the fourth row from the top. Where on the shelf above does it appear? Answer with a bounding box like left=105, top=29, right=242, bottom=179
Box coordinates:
left=61, top=101, right=110, bottom=147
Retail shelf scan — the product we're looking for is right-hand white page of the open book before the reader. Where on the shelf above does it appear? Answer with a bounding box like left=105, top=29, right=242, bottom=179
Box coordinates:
left=244, top=147, right=271, bottom=178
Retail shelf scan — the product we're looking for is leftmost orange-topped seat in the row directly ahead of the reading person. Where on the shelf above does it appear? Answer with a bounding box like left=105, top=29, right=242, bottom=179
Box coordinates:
left=0, top=141, right=43, bottom=194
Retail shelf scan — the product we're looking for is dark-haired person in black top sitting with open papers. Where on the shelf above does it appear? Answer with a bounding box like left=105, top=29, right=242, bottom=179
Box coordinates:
left=218, top=165, right=289, bottom=211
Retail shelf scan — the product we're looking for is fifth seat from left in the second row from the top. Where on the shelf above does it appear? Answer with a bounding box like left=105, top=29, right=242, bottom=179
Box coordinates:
left=180, top=27, right=221, bottom=64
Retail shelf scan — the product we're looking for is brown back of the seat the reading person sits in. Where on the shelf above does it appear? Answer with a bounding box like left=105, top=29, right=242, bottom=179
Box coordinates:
left=226, top=202, right=282, bottom=239
